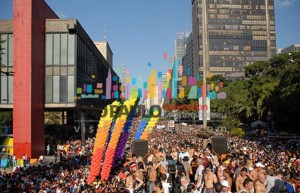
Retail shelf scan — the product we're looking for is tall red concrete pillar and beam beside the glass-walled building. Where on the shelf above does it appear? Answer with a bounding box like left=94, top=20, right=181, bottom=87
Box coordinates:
left=13, top=0, right=58, bottom=158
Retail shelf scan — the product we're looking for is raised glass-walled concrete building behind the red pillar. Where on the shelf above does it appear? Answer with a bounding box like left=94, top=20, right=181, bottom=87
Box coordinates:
left=0, top=19, right=120, bottom=110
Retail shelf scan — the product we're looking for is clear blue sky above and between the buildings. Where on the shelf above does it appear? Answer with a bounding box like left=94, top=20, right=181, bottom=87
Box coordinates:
left=0, top=0, right=300, bottom=80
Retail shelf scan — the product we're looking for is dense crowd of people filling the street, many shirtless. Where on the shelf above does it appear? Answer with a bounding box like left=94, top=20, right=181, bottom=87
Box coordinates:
left=0, top=121, right=300, bottom=193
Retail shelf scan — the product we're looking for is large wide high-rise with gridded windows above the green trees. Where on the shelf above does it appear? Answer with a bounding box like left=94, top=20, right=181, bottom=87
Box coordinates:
left=192, top=0, right=276, bottom=79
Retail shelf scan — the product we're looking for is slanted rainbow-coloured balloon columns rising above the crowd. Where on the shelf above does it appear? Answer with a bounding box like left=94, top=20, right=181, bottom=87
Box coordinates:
left=88, top=98, right=159, bottom=183
